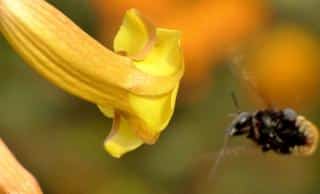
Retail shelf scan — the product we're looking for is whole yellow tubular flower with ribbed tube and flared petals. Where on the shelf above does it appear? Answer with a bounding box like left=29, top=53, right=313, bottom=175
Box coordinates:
left=0, top=0, right=184, bottom=157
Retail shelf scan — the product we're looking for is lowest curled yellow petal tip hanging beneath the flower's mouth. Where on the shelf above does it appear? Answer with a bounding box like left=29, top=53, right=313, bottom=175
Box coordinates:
left=104, top=114, right=143, bottom=158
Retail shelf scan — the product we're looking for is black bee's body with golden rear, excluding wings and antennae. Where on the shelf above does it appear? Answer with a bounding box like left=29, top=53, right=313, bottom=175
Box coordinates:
left=228, top=108, right=319, bottom=156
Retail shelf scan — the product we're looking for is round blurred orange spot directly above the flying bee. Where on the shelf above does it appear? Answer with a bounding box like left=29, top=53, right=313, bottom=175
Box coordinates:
left=245, top=24, right=320, bottom=108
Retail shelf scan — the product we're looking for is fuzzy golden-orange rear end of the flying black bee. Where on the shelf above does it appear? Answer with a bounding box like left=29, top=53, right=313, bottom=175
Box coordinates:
left=292, top=116, right=319, bottom=156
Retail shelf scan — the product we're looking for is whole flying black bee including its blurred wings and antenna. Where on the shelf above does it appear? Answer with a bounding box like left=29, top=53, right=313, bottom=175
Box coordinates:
left=209, top=58, right=319, bottom=178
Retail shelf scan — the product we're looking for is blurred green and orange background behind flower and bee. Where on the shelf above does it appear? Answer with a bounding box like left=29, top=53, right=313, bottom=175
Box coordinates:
left=0, top=0, right=320, bottom=194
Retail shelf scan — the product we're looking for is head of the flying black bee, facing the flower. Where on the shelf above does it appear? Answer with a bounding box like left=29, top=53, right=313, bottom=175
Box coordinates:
left=229, top=112, right=252, bottom=136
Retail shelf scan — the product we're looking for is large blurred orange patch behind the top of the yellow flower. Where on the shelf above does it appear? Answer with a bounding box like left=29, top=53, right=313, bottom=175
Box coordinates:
left=92, top=0, right=269, bottom=87
